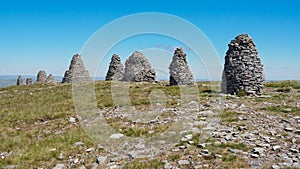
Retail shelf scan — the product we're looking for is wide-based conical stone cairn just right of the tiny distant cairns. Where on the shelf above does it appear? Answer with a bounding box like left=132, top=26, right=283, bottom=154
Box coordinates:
left=62, top=54, right=91, bottom=83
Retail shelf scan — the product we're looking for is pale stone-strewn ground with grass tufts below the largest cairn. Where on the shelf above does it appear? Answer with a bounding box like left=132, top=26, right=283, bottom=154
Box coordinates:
left=1, top=81, right=300, bottom=169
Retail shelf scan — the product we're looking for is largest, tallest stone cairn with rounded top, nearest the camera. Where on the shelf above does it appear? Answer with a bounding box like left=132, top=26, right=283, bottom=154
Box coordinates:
left=222, top=34, right=265, bottom=95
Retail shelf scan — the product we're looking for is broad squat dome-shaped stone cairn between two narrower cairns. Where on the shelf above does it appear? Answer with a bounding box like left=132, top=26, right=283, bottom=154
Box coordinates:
left=123, top=51, right=156, bottom=82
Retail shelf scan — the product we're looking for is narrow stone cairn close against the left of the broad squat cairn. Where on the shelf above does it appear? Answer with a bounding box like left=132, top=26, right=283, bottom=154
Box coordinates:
left=105, top=54, right=124, bottom=80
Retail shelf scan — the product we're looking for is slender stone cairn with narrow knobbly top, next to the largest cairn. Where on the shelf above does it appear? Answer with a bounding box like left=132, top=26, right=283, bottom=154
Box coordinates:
left=169, top=48, right=195, bottom=86
